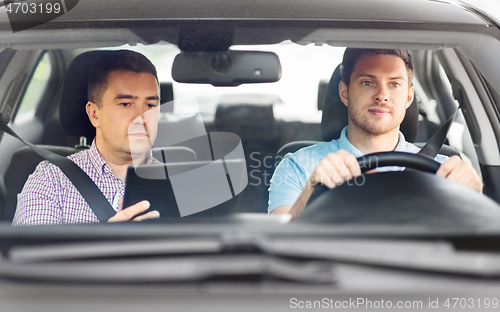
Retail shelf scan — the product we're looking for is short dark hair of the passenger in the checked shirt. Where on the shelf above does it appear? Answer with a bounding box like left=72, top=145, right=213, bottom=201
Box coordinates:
left=87, top=50, right=158, bottom=107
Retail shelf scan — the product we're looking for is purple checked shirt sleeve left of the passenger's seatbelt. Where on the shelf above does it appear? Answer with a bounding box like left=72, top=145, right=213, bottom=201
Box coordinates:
left=12, top=161, right=62, bottom=226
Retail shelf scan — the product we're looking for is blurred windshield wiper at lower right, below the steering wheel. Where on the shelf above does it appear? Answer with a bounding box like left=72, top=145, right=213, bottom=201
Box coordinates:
left=268, top=239, right=500, bottom=278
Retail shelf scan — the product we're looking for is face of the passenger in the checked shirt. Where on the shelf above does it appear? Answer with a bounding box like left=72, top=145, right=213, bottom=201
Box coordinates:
left=87, top=71, right=159, bottom=159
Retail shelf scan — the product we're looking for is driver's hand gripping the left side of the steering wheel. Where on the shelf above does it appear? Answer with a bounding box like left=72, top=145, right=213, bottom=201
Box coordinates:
left=307, top=150, right=361, bottom=189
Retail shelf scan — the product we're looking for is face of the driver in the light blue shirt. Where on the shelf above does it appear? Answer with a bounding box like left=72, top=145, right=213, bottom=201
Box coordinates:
left=339, top=55, right=413, bottom=135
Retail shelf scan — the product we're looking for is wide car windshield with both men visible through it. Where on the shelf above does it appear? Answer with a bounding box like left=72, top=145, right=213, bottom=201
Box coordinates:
left=0, top=0, right=500, bottom=238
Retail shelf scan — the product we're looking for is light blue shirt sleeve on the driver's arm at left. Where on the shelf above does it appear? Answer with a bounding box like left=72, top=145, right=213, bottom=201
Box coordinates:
left=268, top=154, right=306, bottom=213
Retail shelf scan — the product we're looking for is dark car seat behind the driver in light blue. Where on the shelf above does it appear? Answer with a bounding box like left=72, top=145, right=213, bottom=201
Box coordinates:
left=276, top=65, right=460, bottom=160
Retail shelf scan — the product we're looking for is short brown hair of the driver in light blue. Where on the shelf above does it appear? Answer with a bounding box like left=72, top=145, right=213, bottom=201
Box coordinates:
left=341, top=48, right=413, bottom=87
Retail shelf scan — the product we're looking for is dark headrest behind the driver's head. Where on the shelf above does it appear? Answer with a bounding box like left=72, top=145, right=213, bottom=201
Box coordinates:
left=321, top=65, right=419, bottom=142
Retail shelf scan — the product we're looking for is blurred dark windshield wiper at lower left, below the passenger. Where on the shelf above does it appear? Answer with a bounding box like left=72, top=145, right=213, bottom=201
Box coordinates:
left=0, top=239, right=336, bottom=284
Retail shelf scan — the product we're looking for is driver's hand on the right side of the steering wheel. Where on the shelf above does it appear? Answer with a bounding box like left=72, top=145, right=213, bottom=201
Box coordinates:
left=436, top=155, right=483, bottom=193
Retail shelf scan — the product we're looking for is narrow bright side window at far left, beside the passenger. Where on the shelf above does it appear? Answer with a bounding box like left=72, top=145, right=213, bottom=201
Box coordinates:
left=13, top=52, right=51, bottom=124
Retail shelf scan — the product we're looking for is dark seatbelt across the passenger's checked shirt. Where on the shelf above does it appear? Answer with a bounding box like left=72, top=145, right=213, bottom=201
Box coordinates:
left=0, top=118, right=116, bottom=222
